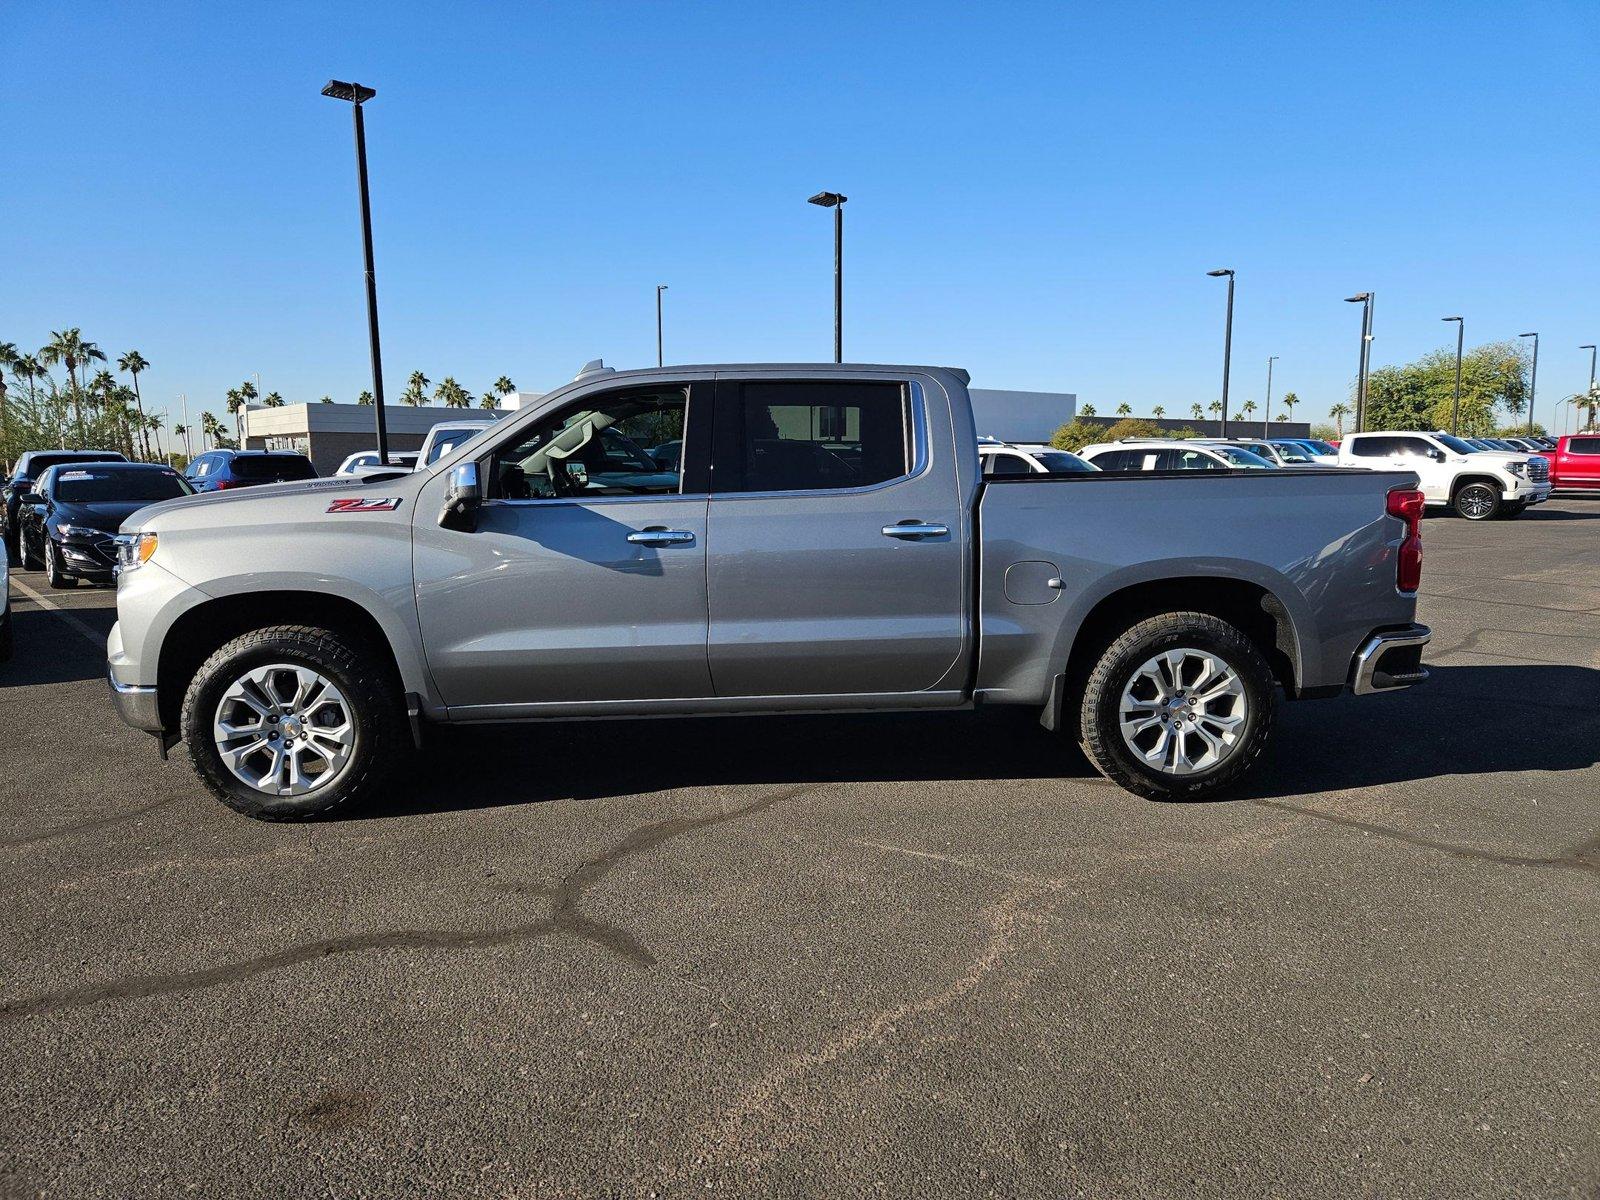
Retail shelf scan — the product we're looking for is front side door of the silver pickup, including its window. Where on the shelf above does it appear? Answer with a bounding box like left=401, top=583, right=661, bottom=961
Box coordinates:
left=413, top=381, right=712, bottom=715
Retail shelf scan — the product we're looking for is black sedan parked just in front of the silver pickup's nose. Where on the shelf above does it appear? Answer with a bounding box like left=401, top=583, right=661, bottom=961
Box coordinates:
left=19, top=462, right=194, bottom=587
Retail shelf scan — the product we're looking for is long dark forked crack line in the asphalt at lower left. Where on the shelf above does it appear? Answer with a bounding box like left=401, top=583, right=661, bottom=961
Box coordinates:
left=0, top=784, right=816, bottom=1022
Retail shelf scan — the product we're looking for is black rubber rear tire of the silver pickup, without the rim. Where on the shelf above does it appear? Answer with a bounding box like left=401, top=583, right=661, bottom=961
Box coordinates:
left=1080, top=613, right=1277, bottom=800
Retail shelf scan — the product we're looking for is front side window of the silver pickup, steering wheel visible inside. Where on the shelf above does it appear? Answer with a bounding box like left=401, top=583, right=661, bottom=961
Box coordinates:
left=486, top=387, right=688, bottom=499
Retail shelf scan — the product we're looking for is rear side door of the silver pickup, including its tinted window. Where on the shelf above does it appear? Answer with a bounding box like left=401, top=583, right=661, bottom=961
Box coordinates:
left=706, top=378, right=971, bottom=702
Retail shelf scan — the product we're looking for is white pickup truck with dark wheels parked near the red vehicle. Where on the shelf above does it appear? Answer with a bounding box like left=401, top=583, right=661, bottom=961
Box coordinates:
left=1339, top=429, right=1550, bottom=522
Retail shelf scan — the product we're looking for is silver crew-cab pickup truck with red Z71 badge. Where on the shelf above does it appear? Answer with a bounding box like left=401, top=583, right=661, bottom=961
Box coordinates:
left=109, top=365, right=1429, bottom=819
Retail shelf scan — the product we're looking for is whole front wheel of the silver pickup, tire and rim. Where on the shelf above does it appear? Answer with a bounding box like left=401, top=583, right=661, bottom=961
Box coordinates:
left=182, top=626, right=411, bottom=821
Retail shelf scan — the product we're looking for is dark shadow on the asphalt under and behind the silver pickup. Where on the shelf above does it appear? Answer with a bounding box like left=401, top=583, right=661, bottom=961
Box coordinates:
left=366, top=664, right=1600, bottom=819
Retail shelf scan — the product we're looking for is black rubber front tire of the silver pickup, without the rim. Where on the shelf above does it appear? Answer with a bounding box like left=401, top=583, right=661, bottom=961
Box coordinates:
left=182, top=626, right=411, bottom=821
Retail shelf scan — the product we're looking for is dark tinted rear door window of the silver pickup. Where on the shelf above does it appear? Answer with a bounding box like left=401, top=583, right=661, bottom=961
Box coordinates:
left=715, top=382, right=907, bottom=491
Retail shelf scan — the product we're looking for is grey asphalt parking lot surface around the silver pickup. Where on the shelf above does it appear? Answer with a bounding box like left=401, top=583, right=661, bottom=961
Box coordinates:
left=0, top=499, right=1600, bottom=1197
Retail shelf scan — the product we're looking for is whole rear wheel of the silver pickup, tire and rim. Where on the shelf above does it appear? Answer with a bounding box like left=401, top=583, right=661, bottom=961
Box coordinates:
left=1082, top=613, right=1277, bottom=800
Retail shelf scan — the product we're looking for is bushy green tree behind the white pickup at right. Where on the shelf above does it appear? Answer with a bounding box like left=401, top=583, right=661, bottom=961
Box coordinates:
left=1365, top=342, right=1528, bottom=437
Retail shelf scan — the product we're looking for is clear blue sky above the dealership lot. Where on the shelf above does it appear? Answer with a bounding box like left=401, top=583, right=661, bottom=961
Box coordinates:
left=0, top=0, right=1600, bottom=432
